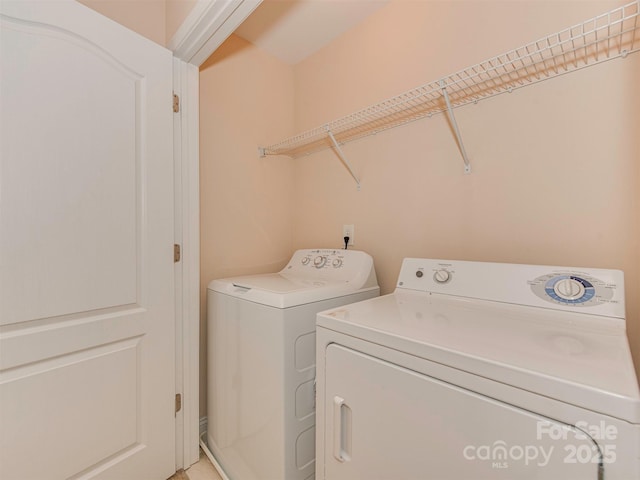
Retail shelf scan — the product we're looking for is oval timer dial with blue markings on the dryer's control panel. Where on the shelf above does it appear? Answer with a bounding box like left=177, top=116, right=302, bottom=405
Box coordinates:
left=529, top=272, right=615, bottom=307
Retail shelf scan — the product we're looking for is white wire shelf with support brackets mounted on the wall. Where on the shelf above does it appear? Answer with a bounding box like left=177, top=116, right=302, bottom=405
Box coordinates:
left=259, top=0, right=640, bottom=165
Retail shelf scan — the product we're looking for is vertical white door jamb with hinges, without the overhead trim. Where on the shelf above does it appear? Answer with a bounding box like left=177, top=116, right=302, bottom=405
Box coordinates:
left=173, top=58, right=200, bottom=469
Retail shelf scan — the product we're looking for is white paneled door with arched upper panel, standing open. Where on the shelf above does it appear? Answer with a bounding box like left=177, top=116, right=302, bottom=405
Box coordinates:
left=0, top=0, right=175, bottom=480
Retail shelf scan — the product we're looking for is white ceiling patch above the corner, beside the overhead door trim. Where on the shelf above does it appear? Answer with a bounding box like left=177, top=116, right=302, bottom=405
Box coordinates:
left=235, top=0, right=389, bottom=65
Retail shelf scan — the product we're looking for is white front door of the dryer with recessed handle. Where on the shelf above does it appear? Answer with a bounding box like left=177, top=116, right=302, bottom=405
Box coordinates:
left=318, top=344, right=599, bottom=480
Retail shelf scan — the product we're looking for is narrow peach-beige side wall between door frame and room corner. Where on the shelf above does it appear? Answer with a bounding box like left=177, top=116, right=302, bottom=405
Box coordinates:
left=200, top=35, right=293, bottom=415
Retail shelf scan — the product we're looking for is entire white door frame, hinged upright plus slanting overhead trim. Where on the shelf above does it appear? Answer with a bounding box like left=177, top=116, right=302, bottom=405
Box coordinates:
left=168, top=0, right=262, bottom=469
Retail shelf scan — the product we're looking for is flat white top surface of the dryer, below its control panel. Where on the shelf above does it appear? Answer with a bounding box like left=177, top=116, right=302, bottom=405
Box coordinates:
left=317, top=290, right=640, bottom=424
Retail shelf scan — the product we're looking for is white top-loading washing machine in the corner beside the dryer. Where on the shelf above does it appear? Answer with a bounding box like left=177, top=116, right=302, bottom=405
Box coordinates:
left=207, top=250, right=380, bottom=480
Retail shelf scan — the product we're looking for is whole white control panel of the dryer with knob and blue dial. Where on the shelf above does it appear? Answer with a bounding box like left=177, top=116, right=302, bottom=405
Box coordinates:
left=397, top=258, right=625, bottom=318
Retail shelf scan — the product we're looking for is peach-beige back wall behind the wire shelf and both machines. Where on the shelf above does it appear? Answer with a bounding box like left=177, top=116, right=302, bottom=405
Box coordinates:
left=292, top=1, right=640, bottom=371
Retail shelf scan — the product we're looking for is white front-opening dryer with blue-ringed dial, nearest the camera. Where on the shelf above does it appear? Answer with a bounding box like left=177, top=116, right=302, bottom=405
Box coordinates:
left=316, top=259, right=640, bottom=480
